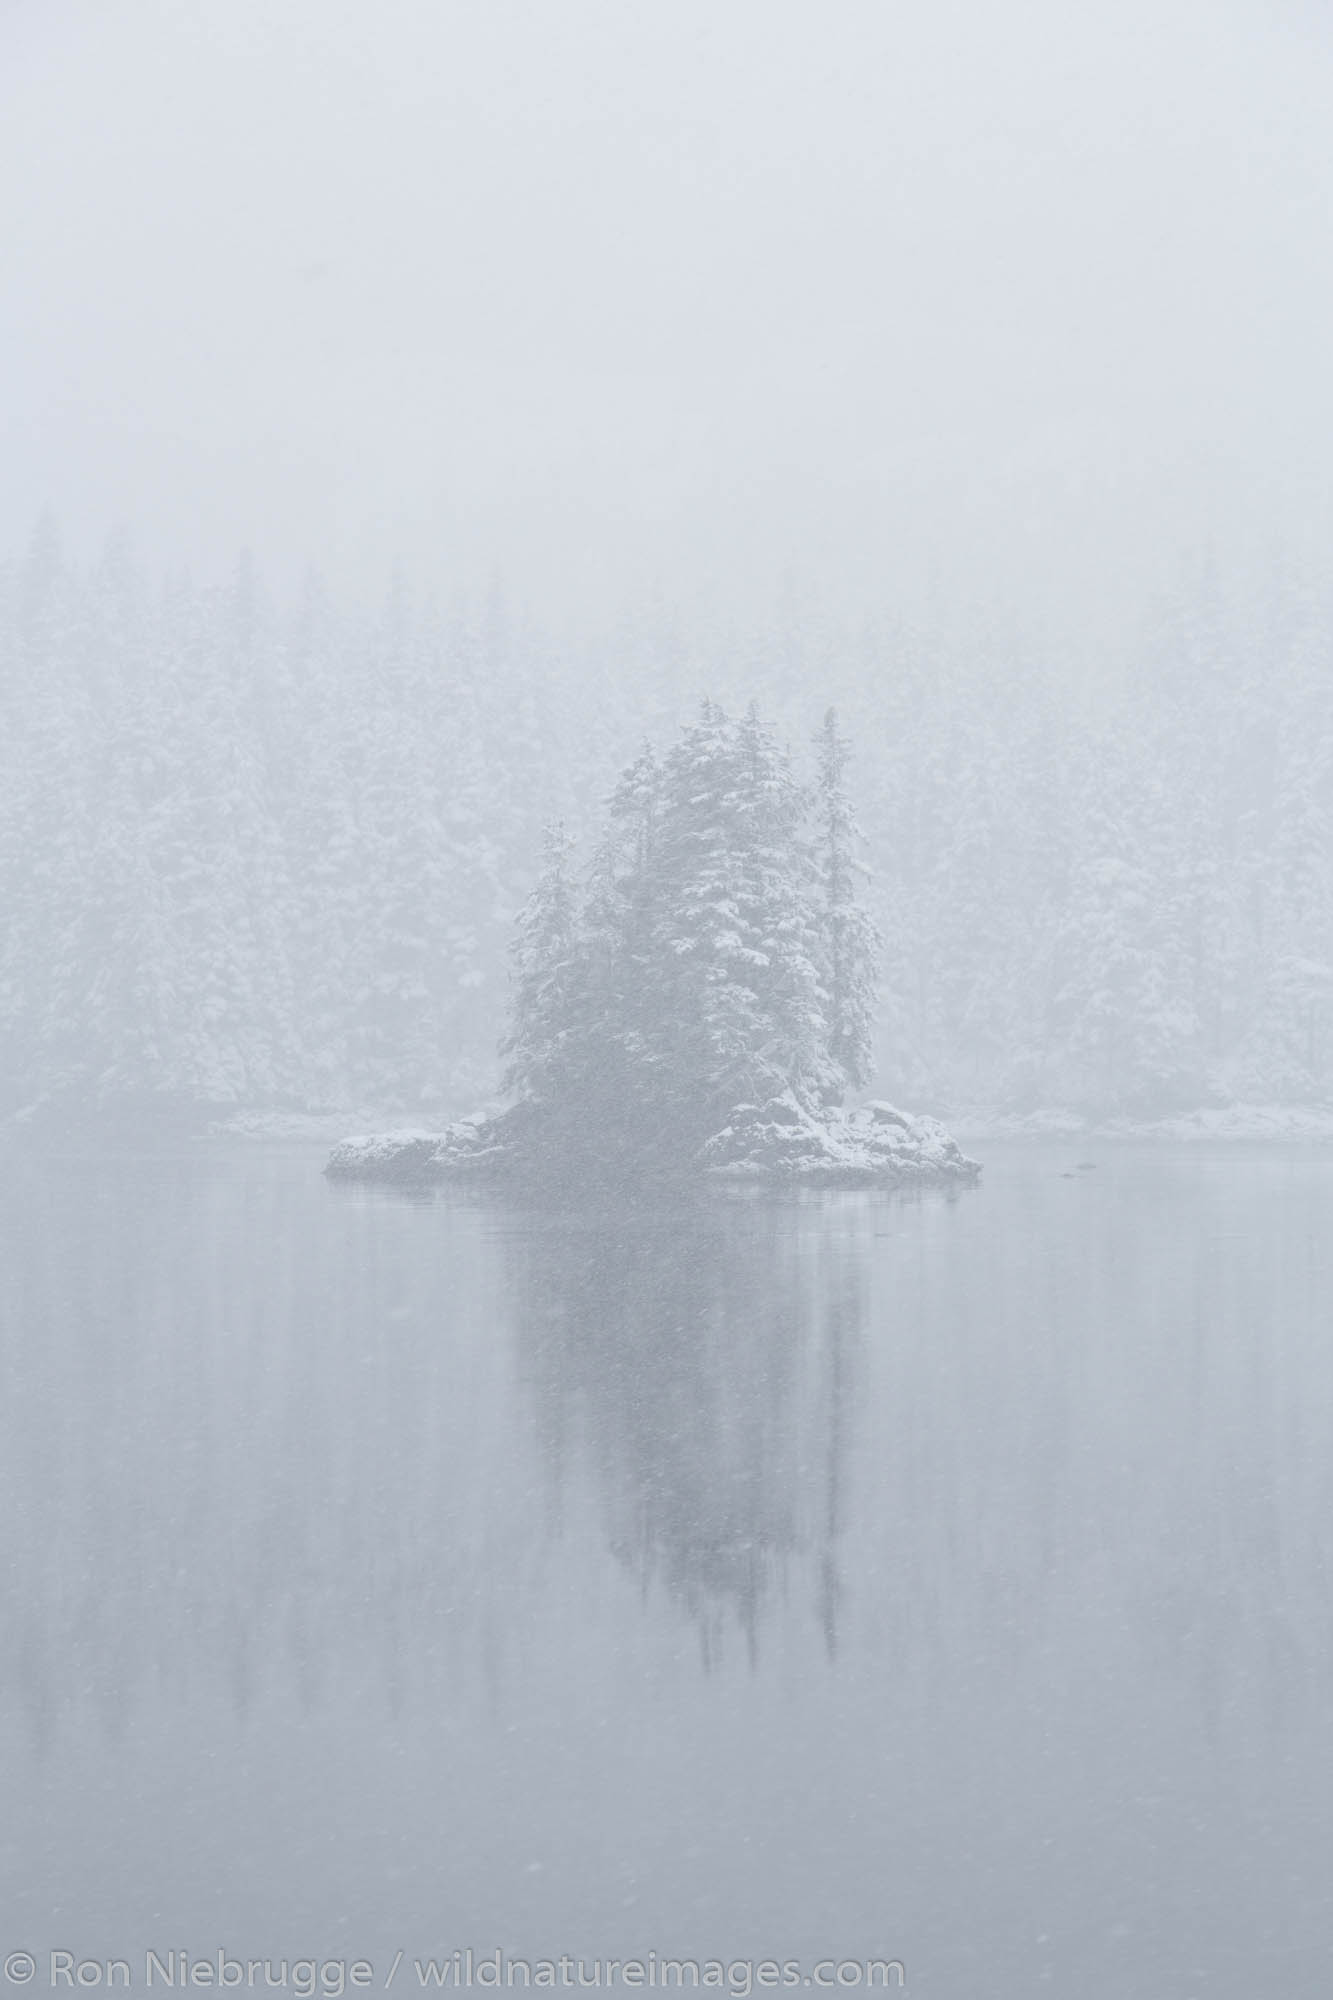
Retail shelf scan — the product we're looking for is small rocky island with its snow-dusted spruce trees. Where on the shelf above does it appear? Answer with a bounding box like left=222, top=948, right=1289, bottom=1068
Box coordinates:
left=326, top=702, right=981, bottom=1192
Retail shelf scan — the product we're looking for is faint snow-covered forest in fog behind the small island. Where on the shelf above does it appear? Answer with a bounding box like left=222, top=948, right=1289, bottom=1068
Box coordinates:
left=0, top=524, right=1333, bottom=1114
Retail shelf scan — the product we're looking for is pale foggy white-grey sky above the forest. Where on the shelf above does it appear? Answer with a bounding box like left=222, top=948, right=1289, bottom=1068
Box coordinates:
left=0, top=0, right=1333, bottom=624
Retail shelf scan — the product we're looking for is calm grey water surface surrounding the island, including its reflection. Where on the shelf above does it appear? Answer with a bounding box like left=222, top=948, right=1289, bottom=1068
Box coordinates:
left=0, top=1146, right=1333, bottom=2000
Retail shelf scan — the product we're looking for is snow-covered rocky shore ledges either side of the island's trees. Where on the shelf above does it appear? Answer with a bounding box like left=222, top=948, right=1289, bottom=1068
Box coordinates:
left=324, top=1092, right=981, bottom=1188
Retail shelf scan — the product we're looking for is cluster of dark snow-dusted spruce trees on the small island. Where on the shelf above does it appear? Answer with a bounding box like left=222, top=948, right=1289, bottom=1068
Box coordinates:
left=492, top=702, right=875, bottom=1158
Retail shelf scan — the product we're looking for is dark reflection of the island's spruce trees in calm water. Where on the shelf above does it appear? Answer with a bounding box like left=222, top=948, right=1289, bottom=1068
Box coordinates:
left=500, top=1196, right=865, bottom=1664
